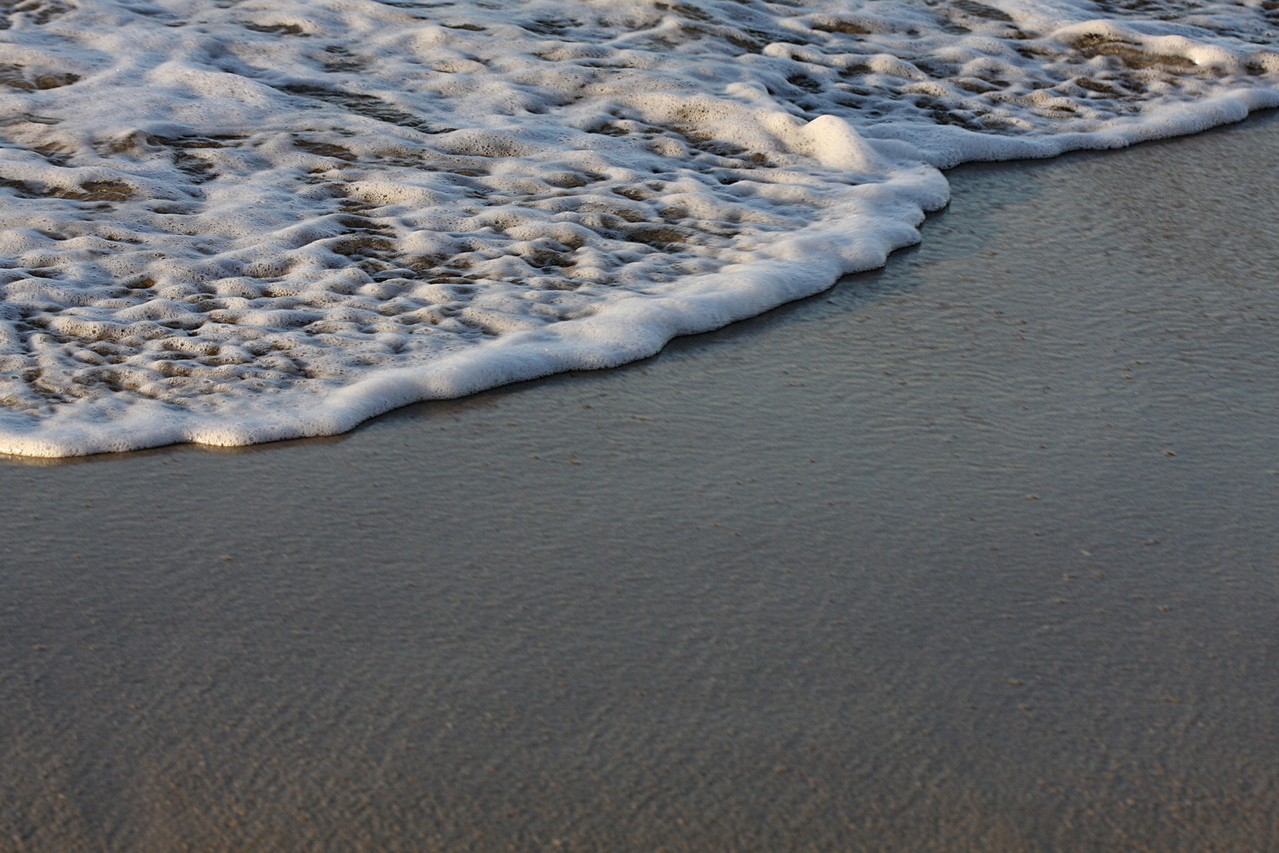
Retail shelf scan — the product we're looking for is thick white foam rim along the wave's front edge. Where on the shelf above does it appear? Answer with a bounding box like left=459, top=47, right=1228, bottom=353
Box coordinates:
left=0, top=104, right=1279, bottom=460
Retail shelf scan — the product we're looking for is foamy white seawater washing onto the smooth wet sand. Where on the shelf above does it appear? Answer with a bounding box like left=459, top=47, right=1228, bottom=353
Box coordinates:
left=0, top=0, right=1279, bottom=457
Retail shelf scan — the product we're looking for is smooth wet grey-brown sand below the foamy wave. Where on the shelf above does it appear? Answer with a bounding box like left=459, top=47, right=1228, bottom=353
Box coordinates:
left=0, top=118, right=1279, bottom=850
